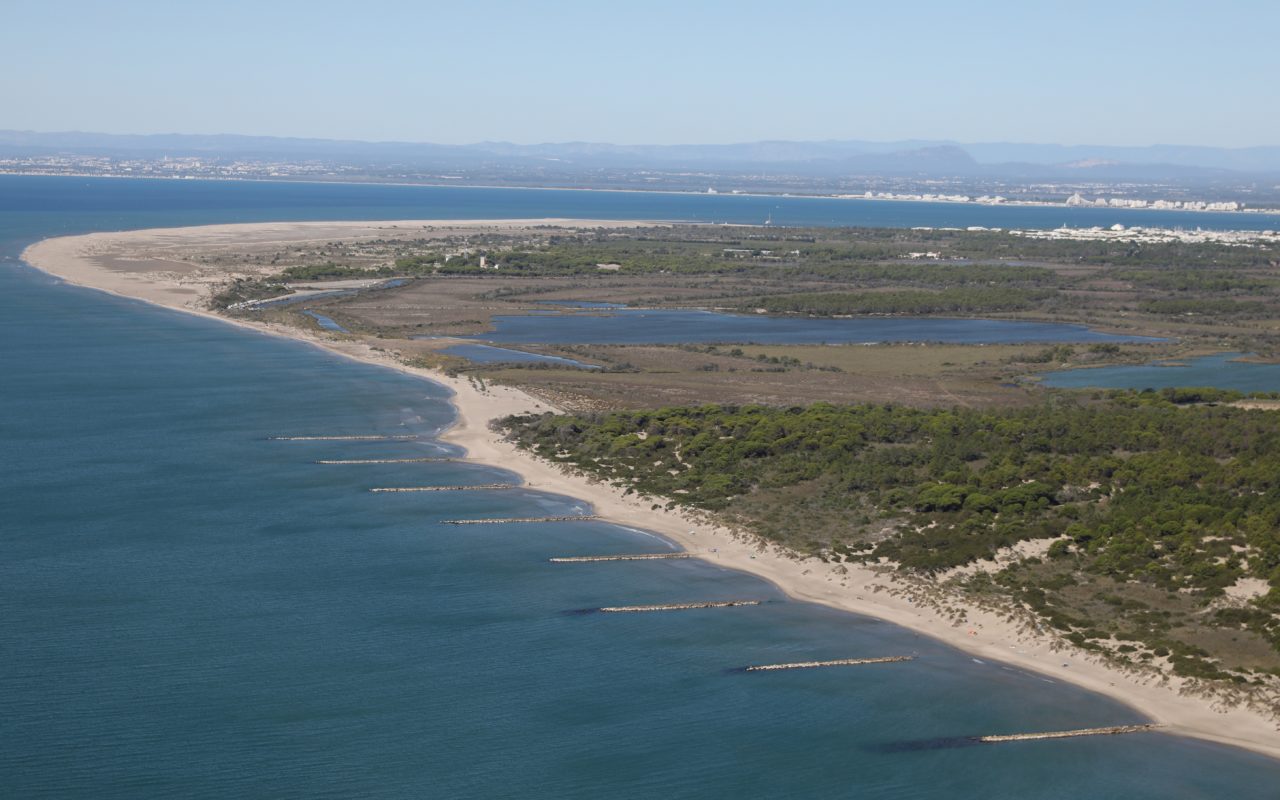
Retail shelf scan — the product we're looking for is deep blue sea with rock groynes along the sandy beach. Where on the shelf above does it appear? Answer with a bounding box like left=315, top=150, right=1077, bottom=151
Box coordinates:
left=0, top=180, right=1280, bottom=800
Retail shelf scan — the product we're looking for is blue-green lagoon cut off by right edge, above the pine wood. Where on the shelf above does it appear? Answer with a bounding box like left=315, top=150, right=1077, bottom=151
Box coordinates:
left=1041, top=353, right=1280, bottom=392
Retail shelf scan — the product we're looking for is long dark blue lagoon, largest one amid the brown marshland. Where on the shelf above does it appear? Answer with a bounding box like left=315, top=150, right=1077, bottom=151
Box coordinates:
left=463, top=308, right=1157, bottom=344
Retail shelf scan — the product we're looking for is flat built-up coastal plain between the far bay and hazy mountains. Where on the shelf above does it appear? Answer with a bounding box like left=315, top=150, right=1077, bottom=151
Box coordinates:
left=0, top=150, right=1280, bottom=212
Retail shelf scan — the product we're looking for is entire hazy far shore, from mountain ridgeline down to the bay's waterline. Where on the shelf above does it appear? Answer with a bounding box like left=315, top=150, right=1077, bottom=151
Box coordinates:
left=10, top=131, right=1280, bottom=211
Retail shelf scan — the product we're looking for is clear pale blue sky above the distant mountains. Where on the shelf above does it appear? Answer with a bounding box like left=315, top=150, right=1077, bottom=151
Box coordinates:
left=0, top=0, right=1280, bottom=146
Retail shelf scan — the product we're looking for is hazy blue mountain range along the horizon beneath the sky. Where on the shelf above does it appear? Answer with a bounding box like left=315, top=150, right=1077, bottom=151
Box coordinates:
left=0, top=131, right=1280, bottom=180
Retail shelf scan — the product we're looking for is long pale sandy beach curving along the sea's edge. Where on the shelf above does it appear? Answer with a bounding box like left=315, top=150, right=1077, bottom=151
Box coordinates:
left=23, top=220, right=1280, bottom=758
